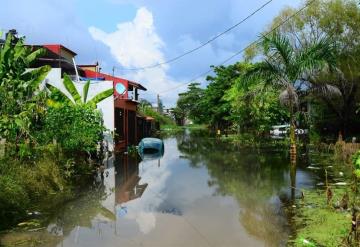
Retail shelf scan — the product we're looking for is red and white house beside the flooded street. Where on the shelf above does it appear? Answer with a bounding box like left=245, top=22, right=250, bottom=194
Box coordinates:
left=28, top=44, right=152, bottom=151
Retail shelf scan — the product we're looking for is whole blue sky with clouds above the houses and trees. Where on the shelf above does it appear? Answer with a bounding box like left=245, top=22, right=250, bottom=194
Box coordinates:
left=0, top=0, right=301, bottom=106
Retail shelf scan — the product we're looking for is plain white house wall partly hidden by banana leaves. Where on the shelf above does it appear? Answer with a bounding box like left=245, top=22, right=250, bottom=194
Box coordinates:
left=42, top=68, right=115, bottom=151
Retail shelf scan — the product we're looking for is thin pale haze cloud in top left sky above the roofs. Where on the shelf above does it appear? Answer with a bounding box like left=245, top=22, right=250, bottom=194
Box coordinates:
left=0, top=0, right=114, bottom=69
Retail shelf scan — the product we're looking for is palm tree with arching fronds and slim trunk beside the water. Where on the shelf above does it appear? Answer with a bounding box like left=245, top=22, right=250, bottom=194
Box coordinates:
left=244, top=32, right=336, bottom=154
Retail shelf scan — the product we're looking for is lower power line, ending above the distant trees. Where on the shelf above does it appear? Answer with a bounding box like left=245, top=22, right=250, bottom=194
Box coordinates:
left=159, top=0, right=316, bottom=95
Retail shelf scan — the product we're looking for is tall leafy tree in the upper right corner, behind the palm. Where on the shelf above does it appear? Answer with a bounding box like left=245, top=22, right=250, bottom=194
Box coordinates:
left=270, top=0, right=360, bottom=136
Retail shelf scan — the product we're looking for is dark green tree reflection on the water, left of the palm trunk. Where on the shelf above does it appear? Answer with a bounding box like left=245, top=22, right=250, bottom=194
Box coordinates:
left=178, top=132, right=289, bottom=246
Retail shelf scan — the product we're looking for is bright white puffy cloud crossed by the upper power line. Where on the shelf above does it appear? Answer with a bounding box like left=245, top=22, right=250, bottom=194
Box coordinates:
left=89, top=7, right=183, bottom=105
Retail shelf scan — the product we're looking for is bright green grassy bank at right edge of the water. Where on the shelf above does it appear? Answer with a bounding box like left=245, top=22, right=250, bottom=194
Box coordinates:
left=210, top=131, right=359, bottom=247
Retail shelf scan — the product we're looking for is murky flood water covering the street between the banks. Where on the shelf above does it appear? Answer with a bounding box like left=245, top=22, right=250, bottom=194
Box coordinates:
left=2, top=130, right=326, bottom=247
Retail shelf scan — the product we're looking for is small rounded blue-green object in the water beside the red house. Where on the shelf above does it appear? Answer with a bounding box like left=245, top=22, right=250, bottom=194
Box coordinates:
left=138, top=138, right=164, bottom=159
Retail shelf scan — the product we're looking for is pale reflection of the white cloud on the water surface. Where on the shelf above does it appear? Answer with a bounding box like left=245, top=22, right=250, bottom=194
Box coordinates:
left=118, top=140, right=179, bottom=234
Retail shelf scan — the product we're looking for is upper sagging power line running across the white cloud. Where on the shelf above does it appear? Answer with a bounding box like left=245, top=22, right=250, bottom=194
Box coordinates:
left=114, top=0, right=273, bottom=71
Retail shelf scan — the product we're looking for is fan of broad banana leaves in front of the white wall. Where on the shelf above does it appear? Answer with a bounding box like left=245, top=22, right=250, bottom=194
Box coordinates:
left=46, top=74, right=114, bottom=108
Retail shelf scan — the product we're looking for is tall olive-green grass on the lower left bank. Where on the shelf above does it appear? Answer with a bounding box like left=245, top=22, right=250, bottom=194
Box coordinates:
left=0, top=145, right=94, bottom=230
